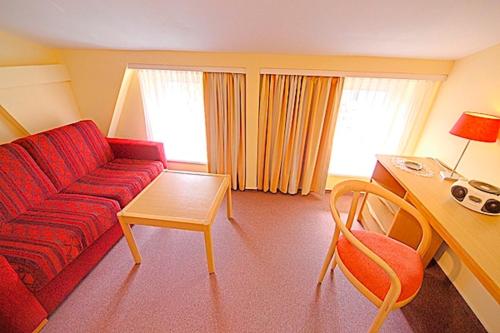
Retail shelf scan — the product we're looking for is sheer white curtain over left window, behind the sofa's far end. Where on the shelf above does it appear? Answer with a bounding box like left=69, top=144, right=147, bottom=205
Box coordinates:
left=138, top=69, right=207, bottom=164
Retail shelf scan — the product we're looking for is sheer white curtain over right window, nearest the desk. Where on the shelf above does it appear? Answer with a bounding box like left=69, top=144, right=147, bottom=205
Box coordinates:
left=329, top=77, right=439, bottom=177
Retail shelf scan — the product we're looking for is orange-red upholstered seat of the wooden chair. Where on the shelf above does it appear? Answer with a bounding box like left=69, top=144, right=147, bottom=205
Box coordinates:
left=337, top=230, right=424, bottom=302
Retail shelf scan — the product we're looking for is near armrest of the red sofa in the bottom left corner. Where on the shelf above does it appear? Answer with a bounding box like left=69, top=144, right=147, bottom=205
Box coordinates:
left=0, top=256, right=47, bottom=333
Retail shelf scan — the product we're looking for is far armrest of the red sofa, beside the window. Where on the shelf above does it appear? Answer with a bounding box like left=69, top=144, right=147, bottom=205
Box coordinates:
left=106, top=138, right=167, bottom=168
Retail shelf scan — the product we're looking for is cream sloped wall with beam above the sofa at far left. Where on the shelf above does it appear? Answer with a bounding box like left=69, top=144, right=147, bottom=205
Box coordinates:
left=0, top=31, right=81, bottom=144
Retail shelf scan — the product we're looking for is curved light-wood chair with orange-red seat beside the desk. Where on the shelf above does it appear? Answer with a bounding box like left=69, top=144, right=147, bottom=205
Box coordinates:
left=318, top=180, right=431, bottom=332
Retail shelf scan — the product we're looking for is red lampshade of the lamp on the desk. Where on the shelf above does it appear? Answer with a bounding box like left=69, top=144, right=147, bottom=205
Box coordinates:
left=450, top=111, right=500, bottom=142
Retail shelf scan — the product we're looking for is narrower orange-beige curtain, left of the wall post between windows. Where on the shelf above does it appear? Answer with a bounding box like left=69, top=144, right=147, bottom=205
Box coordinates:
left=203, top=73, right=246, bottom=190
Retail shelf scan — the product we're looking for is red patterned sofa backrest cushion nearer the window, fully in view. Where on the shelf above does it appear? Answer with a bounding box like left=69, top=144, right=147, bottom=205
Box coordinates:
left=15, top=120, right=113, bottom=191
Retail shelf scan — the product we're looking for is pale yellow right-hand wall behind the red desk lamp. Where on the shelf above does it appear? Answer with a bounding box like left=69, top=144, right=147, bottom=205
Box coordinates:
left=417, top=45, right=500, bottom=186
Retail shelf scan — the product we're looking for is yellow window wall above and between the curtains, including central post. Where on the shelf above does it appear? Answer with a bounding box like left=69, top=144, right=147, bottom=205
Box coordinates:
left=60, top=49, right=453, bottom=188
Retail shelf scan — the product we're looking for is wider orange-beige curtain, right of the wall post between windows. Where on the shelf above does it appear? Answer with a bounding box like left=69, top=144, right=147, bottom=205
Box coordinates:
left=257, top=74, right=343, bottom=195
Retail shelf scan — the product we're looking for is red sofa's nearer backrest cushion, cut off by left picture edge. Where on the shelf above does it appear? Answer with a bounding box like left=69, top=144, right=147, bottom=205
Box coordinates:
left=0, top=143, right=57, bottom=223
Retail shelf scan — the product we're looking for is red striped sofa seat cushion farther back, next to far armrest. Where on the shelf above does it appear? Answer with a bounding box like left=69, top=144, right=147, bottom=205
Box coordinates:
left=63, top=159, right=163, bottom=207
